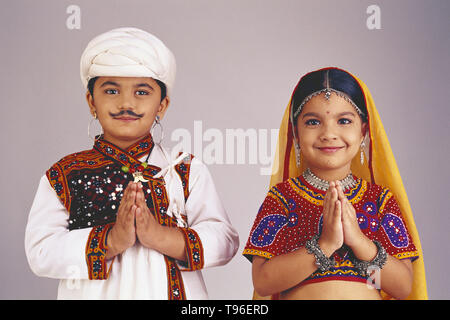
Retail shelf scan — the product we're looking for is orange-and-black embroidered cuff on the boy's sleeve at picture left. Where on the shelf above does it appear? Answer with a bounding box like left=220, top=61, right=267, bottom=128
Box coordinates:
left=86, top=223, right=113, bottom=280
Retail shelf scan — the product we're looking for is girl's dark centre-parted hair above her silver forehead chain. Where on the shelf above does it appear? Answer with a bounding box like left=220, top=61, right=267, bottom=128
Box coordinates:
left=292, top=68, right=367, bottom=124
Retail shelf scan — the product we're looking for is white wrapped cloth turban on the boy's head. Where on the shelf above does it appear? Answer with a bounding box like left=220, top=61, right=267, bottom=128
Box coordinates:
left=80, top=28, right=176, bottom=95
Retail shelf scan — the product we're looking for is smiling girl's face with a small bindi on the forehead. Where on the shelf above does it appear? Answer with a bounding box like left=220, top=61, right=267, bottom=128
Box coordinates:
left=297, top=93, right=366, bottom=181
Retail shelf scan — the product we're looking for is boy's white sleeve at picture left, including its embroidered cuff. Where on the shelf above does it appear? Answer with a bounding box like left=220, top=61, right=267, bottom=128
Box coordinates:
left=25, top=176, right=108, bottom=279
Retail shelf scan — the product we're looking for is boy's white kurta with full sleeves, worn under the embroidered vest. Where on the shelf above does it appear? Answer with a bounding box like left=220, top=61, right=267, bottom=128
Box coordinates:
left=25, top=145, right=239, bottom=299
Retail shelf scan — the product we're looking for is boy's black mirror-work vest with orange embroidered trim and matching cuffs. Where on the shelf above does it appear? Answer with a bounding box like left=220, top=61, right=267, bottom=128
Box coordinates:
left=46, top=135, right=203, bottom=300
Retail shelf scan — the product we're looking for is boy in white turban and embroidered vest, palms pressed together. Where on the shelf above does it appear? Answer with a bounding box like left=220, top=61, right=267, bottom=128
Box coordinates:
left=25, top=28, right=239, bottom=300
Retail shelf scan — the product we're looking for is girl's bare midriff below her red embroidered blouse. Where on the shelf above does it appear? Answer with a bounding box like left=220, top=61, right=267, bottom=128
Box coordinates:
left=280, top=280, right=381, bottom=300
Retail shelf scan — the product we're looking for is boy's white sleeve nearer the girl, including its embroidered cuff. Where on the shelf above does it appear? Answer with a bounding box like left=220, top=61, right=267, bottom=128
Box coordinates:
left=180, top=158, right=239, bottom=271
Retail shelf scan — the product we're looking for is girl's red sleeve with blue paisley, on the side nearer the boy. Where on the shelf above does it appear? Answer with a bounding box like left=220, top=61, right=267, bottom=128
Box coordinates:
left=243, top=186, right=288, bottom=262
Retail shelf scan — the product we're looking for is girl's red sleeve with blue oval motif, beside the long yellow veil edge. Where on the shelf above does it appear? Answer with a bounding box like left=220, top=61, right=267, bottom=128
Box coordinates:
left=377, top=189, right=419, bottom=261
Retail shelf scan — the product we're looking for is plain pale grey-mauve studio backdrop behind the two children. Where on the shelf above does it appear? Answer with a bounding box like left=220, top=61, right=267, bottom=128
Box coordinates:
left=0, top=0, right=450, bottom=299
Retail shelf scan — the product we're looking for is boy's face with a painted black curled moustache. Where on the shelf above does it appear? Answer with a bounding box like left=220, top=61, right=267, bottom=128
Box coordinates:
left=86, top=77, right=170, bottom=149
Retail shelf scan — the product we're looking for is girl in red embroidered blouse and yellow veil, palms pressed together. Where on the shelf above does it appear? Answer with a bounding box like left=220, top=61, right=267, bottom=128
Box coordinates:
left=244, top=68, right=427, bottom=299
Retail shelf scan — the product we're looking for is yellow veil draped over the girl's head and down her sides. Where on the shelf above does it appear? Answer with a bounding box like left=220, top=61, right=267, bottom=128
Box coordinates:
left=253, top=68, right=428, bottom=300
